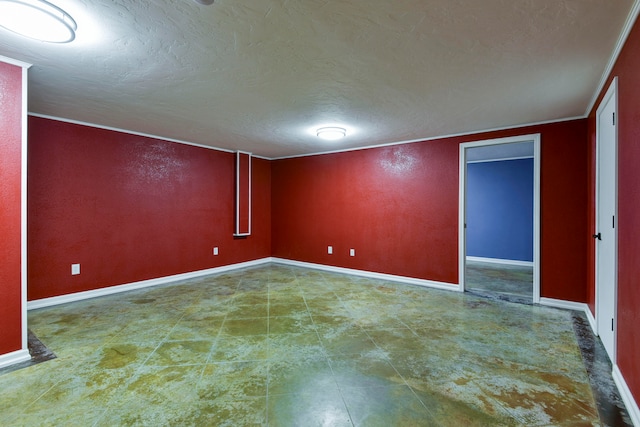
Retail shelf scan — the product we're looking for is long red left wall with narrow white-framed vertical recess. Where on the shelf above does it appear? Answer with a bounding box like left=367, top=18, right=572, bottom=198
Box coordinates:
left=28, top=117, right=271, bottom=300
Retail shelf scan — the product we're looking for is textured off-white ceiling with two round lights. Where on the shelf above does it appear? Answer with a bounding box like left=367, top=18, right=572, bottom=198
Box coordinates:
left=0, top=0, right=633, bottom=158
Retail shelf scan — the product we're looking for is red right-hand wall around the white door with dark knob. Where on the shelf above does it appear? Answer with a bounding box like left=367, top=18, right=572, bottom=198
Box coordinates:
left=589, top=15, right=640, bottom=408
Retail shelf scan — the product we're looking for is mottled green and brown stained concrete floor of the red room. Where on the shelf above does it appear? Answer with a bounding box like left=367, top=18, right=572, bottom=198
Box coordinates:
left=0, top=265, right=624, bottom=426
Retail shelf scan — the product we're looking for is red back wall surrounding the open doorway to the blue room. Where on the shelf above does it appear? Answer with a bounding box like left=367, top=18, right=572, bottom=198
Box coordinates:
left=272, top=120, right=588, bottom=302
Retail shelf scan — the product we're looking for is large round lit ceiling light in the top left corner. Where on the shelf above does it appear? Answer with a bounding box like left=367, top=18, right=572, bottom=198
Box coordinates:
left=0, top=0, right=78, bottom=43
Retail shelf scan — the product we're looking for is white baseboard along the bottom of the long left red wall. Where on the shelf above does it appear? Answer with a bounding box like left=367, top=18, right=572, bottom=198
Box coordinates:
left=28, top=257, right=271, bottom=310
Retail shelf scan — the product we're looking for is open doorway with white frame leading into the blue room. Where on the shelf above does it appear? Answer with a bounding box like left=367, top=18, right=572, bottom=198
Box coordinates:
left=459, top=135, right=540, bottom=304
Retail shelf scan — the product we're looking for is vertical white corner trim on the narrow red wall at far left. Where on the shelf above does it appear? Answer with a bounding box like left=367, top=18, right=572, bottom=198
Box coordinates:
left=20, top=62, right=29, bottom=352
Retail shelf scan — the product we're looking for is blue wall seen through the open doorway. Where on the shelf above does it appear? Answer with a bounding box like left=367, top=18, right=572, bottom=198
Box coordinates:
left=467, top=159, right=533, bottom=261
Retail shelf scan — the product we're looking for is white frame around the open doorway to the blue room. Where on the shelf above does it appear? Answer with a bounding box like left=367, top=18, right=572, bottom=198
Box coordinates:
left=458, top=133, right=540, bottom=304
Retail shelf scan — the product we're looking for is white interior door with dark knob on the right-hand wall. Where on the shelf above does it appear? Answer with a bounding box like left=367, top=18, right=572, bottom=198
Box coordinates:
left=593, top=81, right=617, bottom=362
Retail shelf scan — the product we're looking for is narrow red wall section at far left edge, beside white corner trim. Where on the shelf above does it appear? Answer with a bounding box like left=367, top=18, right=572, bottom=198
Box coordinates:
left=0, top=62, right=22, bottom=354
